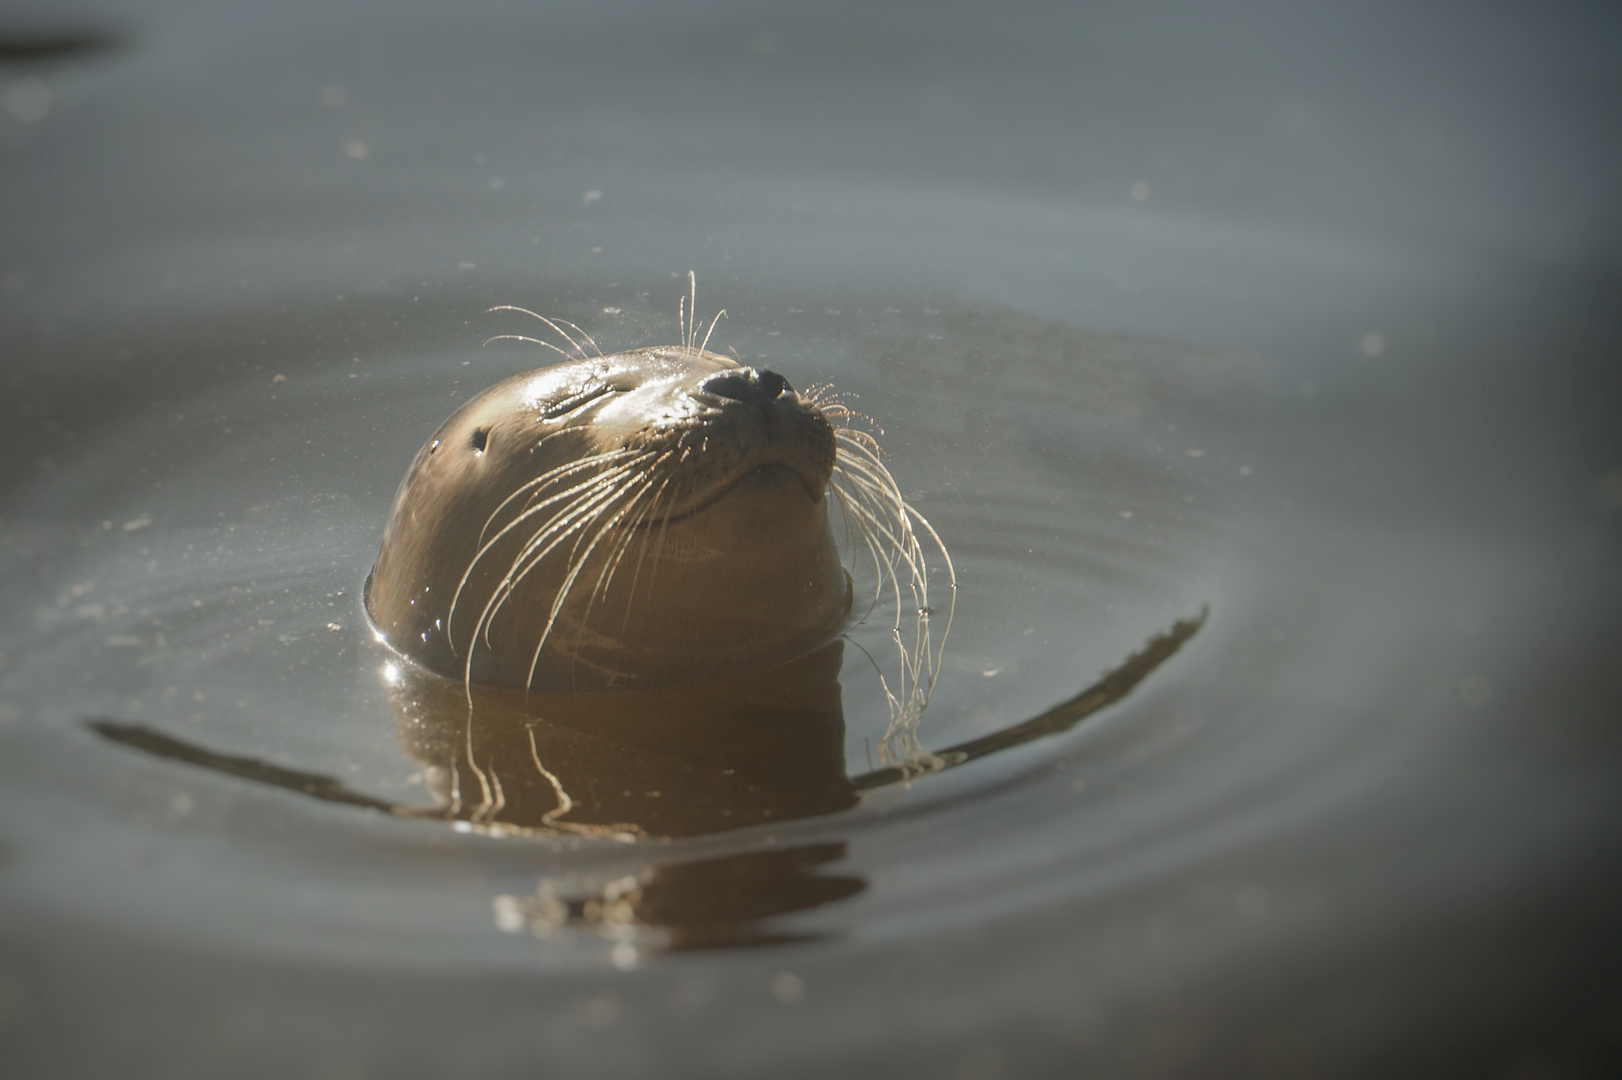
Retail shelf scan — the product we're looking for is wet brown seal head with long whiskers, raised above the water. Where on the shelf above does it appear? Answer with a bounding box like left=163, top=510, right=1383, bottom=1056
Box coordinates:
left=367, top=347, right=852, bottom=692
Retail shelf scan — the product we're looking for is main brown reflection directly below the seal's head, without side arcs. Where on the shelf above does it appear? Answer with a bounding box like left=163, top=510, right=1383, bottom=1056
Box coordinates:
left=384, top=641, right=856, bottom=840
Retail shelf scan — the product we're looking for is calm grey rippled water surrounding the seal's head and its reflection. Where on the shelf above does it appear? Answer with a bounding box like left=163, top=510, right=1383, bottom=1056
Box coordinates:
left=0, top=6, right=1622, bottom=1077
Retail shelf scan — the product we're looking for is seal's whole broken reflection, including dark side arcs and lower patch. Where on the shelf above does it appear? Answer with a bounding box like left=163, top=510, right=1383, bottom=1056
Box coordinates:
left=88, top=611, right=1205, bottom=952
